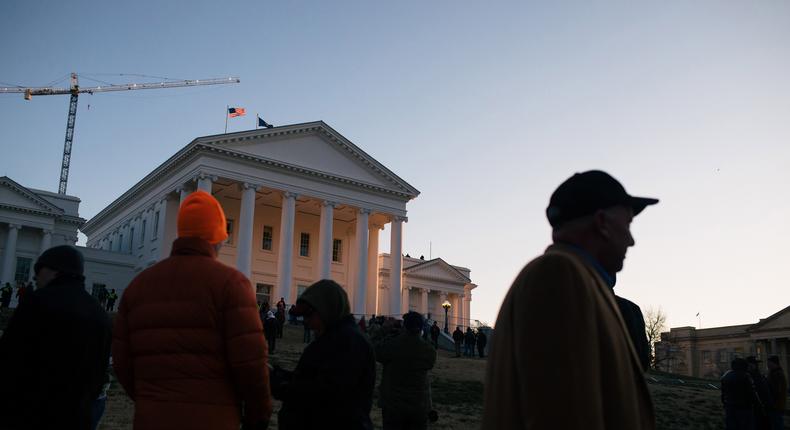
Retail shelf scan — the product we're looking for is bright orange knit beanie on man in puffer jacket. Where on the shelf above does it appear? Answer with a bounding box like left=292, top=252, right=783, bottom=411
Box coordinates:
left=178, top=190, right=228, bottom=245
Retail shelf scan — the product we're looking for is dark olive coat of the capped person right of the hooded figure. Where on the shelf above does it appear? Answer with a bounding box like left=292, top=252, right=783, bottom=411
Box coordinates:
left=375, top=332, right=436, bottom=418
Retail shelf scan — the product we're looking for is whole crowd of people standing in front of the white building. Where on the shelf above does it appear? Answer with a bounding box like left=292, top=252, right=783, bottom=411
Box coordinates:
left=0, top=171, right=787, bottom=430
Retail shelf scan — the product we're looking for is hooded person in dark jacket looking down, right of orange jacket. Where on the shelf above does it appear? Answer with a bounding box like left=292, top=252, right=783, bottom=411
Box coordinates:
left=272, top=279, right=376, bottom=430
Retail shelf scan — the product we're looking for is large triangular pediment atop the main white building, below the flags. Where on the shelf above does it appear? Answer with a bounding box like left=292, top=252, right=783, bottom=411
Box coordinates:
left=198, top=121, right=419, bottom=197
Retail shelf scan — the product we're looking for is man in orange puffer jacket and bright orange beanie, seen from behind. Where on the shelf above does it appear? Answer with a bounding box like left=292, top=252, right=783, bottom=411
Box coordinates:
left=112, top=191, right=272, bottom=430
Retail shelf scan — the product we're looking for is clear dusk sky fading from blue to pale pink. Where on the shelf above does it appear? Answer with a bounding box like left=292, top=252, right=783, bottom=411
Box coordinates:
left=0, top=0, right=790, bottom=327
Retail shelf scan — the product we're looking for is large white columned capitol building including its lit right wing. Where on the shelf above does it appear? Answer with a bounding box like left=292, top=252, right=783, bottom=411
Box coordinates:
left=82, top=121, right=475, bottom=324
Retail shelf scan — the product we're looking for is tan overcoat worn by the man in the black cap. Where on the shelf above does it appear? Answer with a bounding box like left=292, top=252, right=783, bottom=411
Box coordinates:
left=483, top=245, right=655, bottom=430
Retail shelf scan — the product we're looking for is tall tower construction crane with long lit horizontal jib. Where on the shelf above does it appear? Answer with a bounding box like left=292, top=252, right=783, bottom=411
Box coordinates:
left=0, top=73, right=241, bottom=194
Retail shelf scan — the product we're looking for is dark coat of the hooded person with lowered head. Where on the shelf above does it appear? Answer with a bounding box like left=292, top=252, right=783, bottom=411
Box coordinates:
left=277, top=315, right=376, bottom=430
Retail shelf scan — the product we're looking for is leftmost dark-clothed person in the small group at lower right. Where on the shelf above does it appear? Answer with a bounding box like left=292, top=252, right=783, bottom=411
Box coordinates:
left=721, top=358, right=756, bottom=430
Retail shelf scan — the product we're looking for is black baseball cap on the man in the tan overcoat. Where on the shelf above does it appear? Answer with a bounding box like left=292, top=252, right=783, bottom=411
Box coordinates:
left=546, top=170, right=658, bottom=227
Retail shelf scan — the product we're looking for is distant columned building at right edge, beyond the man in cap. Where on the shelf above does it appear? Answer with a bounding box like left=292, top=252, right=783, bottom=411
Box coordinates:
left=656, top=306, right=790, bottom=378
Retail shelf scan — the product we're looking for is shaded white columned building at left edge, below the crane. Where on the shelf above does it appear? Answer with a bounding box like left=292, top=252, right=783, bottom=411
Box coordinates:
left=0, top=176, right=135, bottom=307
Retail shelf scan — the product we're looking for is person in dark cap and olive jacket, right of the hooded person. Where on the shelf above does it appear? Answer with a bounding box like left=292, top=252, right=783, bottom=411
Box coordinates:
left=375, top=312, right=436, bottom=430
